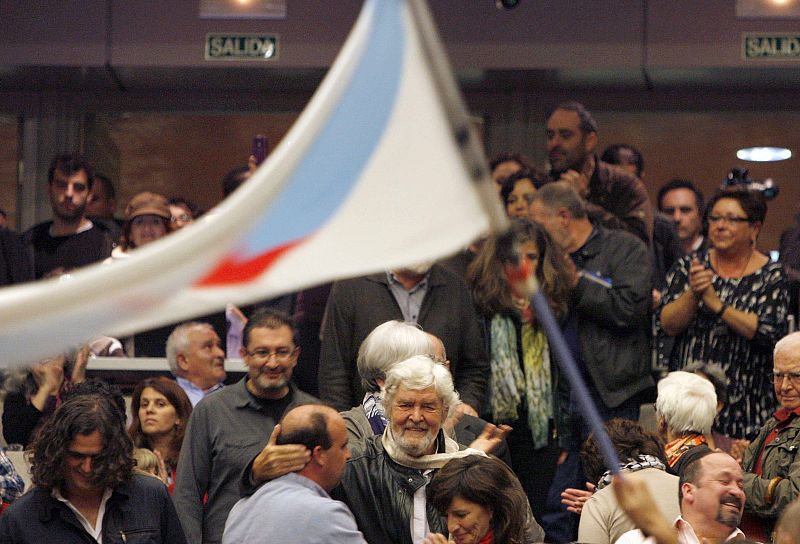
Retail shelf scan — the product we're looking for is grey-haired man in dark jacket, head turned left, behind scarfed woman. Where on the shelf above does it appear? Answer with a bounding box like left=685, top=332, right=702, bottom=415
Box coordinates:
left=530, top=181, right=653, bottom=430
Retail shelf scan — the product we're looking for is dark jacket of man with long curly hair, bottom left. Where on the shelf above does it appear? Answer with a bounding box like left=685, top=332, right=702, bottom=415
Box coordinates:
left=0, top=474, right=186, bottom=544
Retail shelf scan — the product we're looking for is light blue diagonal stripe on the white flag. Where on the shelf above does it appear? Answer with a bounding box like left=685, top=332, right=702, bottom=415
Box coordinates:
left=239, top=0, right=406, bottom=258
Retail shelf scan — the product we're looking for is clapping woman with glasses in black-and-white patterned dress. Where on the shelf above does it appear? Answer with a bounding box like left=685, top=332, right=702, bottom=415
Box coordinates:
left=658, top=189, right=789, bottom=439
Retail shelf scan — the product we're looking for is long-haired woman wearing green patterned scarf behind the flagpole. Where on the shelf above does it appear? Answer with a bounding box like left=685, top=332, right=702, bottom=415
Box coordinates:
left=467, top=219, right=571, bottom=518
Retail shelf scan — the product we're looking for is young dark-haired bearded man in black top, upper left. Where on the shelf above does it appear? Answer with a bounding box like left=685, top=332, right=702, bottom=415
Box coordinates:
left=25, top=155, right=115, bottom=279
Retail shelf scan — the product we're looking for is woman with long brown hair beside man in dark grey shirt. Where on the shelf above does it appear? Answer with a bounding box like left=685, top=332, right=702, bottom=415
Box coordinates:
left=128, top=376, right=192, bottom=493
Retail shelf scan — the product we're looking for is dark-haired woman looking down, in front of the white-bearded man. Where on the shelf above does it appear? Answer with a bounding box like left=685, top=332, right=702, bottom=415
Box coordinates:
left=426, top=455, right=533, bottom=544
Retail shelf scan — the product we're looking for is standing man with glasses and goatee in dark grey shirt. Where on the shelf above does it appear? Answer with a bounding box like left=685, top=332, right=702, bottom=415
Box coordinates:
left=173, top=310, right=318, bottom=544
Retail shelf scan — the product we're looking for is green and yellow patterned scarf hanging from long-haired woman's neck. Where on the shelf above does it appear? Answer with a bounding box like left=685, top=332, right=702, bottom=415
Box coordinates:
left=491, top=314, right=553, bottom=448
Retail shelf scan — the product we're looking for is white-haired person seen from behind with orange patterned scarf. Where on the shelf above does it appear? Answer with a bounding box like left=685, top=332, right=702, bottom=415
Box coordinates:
left=656, top=371, right=717, bottom=475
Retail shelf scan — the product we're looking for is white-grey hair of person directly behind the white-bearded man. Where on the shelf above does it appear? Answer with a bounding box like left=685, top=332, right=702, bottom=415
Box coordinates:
left=356, top=321, right=433, bottom=393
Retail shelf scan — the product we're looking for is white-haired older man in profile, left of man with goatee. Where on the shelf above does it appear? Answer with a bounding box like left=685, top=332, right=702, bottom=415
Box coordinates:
left=166, top=321, right=225, bottom=407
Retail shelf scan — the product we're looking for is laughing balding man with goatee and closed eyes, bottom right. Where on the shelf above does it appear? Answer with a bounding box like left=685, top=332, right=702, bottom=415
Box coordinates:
left=617, top=452, right=745, bottom=544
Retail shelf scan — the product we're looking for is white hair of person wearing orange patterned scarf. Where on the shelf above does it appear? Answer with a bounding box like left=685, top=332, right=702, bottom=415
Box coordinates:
left=656, top=371, right=717, bottom=435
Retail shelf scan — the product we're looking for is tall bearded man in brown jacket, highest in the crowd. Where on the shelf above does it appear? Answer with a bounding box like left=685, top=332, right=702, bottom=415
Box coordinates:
left=547, top=102, right=653, bottom=246
